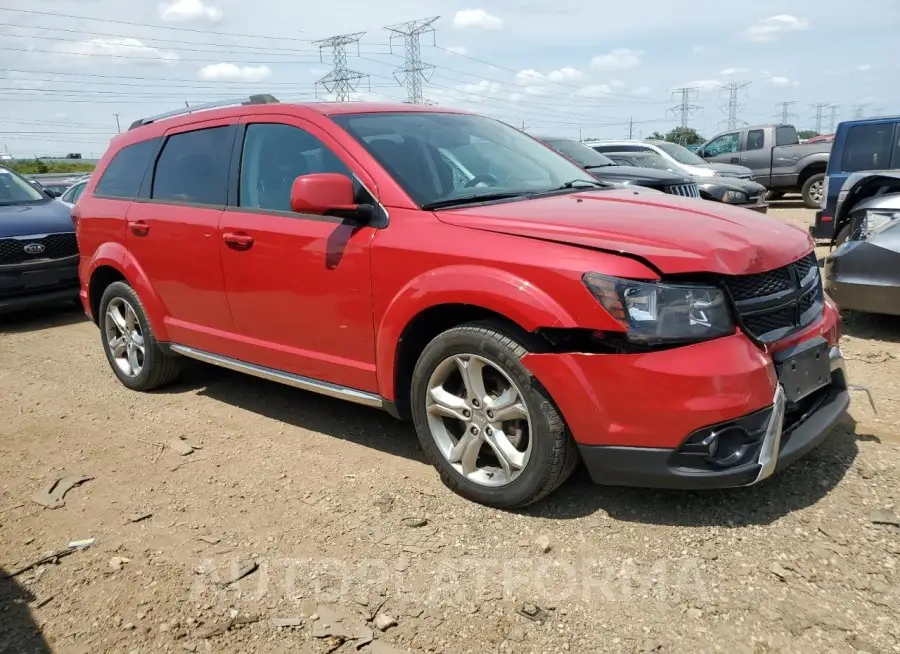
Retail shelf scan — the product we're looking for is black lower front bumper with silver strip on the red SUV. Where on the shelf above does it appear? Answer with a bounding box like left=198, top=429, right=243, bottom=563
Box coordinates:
left=579, top=347, right=850, bottom=490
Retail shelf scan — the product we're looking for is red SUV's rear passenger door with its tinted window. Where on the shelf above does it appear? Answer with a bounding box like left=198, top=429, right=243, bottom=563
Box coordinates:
left=126, top=117, right=238, bottom=351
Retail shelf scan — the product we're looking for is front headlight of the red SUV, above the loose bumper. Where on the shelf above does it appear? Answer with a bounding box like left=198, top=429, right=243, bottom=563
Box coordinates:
left=584, top=273, right=734, bottom=343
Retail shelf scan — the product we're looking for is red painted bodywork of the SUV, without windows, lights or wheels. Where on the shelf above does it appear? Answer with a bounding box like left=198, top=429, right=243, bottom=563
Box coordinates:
left=78, top=103, right=840, bottom=462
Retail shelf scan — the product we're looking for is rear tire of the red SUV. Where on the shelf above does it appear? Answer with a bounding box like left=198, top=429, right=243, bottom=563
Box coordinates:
left=97, top=282, right=179, bottom=391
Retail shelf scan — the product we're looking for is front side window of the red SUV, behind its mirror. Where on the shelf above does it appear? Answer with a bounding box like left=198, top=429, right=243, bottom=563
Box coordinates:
left=238, top=123, right=355, bottom=211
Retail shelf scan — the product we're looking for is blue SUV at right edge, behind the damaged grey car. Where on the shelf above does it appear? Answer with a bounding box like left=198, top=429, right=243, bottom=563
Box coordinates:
left=809, top=116, right=900, bottom=239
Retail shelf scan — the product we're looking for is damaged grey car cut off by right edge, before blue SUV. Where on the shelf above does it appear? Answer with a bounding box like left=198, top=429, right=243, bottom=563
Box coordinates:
left=825, top=171, right=900, bottom=315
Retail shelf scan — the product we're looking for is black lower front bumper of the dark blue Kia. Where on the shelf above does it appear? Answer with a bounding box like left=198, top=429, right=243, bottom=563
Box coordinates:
left=0, top=255, right=79, bottom=312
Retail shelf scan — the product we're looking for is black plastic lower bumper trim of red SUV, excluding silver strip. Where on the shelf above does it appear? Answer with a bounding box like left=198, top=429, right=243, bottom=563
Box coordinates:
left=579, top=387, right=850, bottom=490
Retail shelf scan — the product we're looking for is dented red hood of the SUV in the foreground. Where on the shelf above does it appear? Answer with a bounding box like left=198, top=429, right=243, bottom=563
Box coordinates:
left=435, top=190, right=813, bottom=275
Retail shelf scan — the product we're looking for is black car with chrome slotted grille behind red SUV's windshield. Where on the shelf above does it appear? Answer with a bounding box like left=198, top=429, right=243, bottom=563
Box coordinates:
left=538, top=137, right=700, bottom=198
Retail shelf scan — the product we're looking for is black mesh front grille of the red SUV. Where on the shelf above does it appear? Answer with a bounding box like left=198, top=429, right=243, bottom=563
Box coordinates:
left=723, top=252, right=824, bottom=343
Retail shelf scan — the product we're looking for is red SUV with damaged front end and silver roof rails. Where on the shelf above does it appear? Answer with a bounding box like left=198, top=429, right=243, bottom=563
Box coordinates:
left=74, top=96, right=849, bottom=507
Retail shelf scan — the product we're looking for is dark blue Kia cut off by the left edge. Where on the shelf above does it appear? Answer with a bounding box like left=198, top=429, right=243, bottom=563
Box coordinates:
left=0, top=167, right=78, bottom=312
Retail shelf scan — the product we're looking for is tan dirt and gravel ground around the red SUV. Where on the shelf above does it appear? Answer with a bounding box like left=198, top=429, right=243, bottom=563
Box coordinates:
left=0, top=202, right=900, bottom=654
